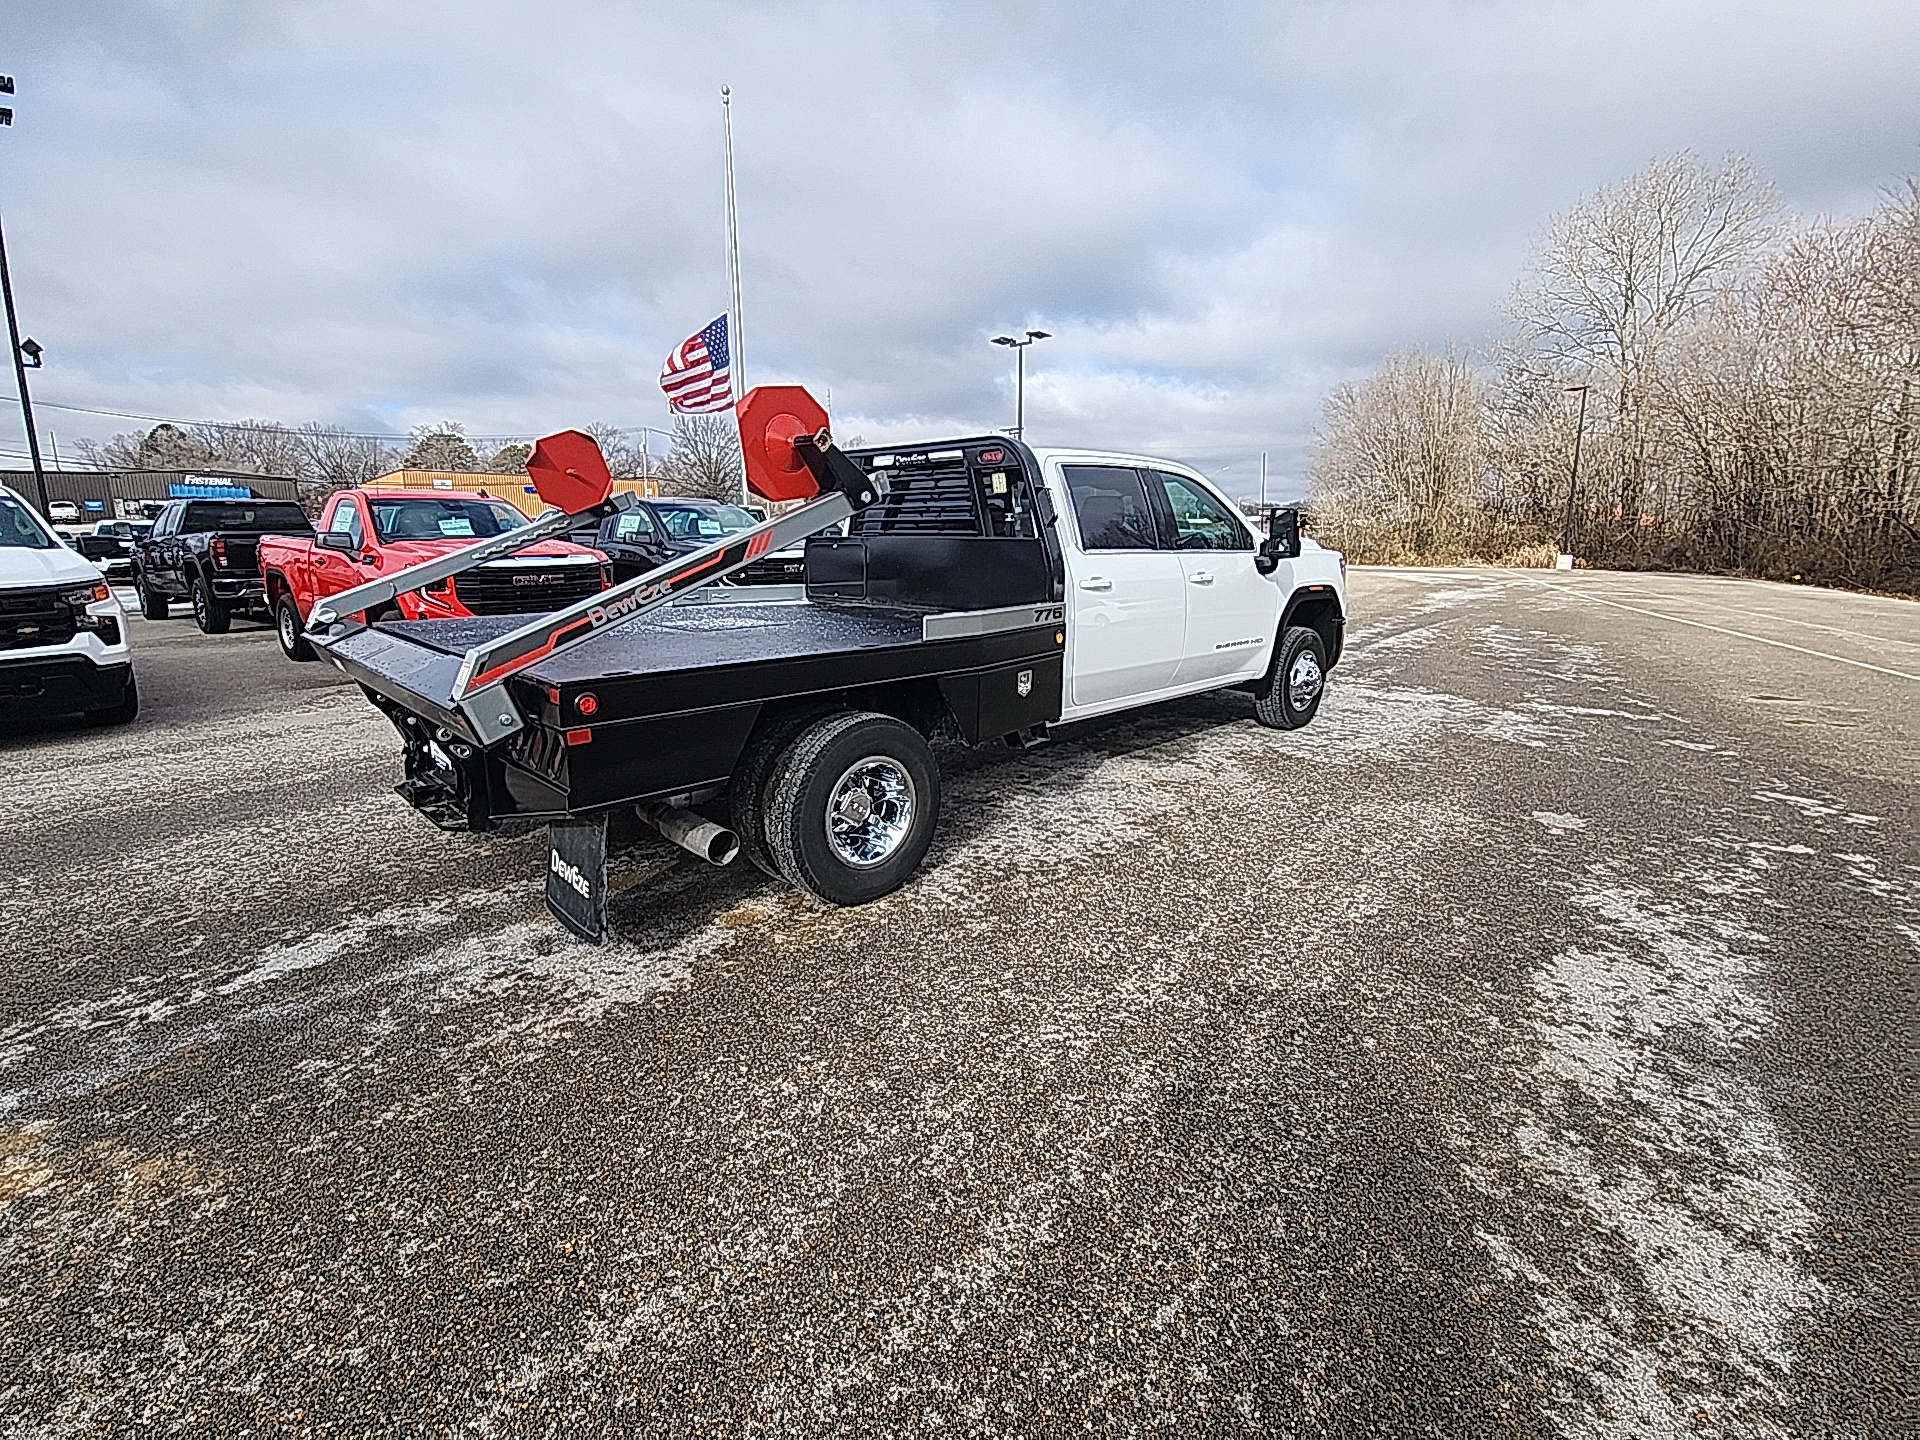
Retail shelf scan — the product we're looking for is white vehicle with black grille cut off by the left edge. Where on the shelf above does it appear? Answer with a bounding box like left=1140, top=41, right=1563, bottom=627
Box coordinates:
left=0, top=486, right=140, bottom=726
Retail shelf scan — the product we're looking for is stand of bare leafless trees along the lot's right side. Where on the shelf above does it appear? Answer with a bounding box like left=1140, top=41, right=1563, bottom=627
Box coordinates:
left=1313, top=157, right=1920, bottom=591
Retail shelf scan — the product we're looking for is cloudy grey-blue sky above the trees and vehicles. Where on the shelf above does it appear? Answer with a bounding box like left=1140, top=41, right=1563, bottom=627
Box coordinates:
left=0, top=0, right=1920, bottom=495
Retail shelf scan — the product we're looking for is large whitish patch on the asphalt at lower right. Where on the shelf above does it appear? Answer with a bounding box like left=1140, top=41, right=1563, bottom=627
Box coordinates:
left=1467, top=868, right=1826, bottom=1436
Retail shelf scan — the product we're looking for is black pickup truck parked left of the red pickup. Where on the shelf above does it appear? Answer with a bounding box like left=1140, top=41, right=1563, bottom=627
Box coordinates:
left=132, top=499, right=313, bottom=636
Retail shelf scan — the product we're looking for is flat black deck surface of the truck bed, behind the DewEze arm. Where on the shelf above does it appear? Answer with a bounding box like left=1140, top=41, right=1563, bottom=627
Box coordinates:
left=378, top=603, right=922, bottom=685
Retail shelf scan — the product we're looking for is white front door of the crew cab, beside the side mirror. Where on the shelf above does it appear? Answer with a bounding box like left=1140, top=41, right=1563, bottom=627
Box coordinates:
left=1148, top=470, right=1281, bottom=685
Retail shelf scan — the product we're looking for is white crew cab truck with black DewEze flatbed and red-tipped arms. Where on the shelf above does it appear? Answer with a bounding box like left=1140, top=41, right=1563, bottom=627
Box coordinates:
left=307, top=388, right=1346, bottom=939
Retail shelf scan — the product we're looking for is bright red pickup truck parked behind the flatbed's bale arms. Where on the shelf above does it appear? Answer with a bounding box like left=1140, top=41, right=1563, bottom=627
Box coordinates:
left=259, top=490, right=611, bottom=660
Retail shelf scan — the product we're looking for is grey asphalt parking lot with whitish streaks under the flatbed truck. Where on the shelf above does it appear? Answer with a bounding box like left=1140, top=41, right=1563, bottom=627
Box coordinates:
left=0, top=570, right=1920, bottom=1436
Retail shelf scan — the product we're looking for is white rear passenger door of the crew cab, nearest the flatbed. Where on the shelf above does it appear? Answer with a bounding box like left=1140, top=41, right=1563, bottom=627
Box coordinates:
left=1060, top=465, right=1187, bottom=705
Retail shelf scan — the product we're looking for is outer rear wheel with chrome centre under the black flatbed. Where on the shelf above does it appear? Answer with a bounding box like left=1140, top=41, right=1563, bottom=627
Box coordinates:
left=766, top=710, right=941, bottom=904
